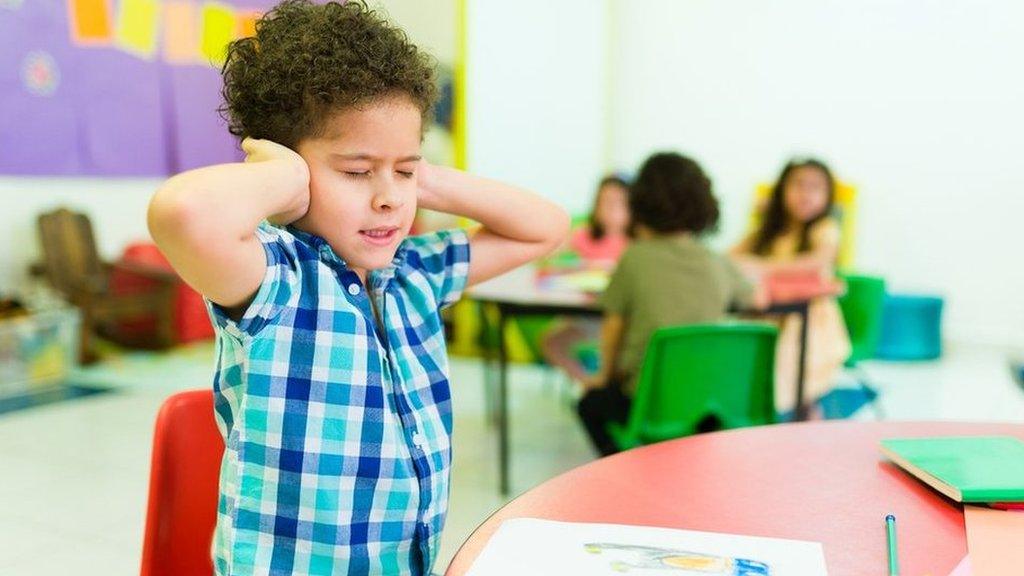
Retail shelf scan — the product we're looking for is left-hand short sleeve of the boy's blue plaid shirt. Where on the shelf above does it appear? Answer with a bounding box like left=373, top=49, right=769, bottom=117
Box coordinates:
left=207, top=222, right=301, bottom=336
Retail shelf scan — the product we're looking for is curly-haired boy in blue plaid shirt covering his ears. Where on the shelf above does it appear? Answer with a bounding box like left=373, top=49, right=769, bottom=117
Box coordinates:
left=150, top=0, right=568, bottom=575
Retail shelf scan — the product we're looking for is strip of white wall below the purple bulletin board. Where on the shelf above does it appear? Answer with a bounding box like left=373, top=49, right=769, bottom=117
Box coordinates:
left=0, top=176, right=161, bottom=293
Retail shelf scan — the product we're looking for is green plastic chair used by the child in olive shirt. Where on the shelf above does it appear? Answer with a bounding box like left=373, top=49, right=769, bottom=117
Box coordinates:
left=608, top=323, right=778, bottom=450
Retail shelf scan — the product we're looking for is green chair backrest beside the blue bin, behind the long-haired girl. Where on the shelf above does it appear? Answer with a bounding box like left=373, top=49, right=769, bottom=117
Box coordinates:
left=839, top=274, right=886, bottom=366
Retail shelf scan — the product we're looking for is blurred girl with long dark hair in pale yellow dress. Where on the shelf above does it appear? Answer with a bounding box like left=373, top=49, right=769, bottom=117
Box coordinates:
left=731, top=159, right=850, bottom=412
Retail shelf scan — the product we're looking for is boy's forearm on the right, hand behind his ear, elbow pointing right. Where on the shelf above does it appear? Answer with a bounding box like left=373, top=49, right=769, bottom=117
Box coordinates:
left=420, top=166, right=568, bottom=245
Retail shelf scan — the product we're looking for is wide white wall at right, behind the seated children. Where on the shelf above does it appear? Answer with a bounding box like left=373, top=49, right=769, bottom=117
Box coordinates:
left=611, top=0, right=1024, bottom=346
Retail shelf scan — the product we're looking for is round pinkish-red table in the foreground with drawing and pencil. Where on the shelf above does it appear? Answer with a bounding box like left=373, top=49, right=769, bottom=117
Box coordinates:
left=446, top=422, right=1024, bottom=576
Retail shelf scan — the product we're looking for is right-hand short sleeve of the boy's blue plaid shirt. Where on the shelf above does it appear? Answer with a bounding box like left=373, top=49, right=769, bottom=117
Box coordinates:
left=404, top=229, right=469, bottom=307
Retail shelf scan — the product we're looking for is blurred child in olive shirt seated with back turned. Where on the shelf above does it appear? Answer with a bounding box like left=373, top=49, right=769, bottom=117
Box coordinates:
left=578, top=153, right=762, bottom=455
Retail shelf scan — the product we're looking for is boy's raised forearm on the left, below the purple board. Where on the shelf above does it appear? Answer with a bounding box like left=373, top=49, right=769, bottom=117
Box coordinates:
left=150, top=160, right=309, bottom=239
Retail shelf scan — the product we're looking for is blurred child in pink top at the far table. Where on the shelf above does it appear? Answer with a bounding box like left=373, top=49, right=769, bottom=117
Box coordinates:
left=541, top=175, right=630, bottom=382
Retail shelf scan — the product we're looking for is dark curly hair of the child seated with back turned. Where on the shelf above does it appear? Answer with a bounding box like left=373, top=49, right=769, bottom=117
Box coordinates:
left=630, top=153, right=719, bottom=234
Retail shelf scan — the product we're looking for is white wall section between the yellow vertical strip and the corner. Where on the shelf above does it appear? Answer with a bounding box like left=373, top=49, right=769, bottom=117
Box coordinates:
left=467, top=0, right=608, bottom=212
